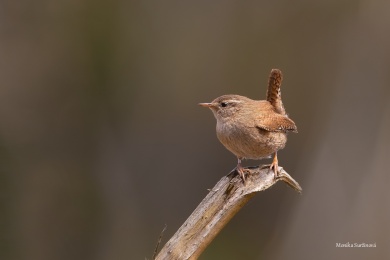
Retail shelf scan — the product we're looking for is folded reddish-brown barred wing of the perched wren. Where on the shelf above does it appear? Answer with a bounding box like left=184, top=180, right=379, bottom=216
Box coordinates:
left=255, top=112, right=298, bottom=133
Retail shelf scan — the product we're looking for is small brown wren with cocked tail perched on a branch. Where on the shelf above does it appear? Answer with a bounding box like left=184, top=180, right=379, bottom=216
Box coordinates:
left=199, top=69, right=298, bottom=182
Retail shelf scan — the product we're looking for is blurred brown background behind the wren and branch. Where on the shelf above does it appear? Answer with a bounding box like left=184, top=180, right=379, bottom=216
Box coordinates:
left=0, top=0, right=390, bottom=260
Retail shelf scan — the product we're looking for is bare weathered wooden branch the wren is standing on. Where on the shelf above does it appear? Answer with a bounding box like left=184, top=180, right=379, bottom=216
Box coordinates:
left=155, top=165, right=302, bottom=260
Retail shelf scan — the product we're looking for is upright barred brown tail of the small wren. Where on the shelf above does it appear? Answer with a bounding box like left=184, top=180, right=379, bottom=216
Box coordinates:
left=267, top=69, right=286, bottom=115
